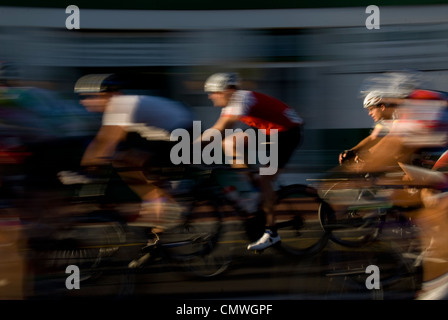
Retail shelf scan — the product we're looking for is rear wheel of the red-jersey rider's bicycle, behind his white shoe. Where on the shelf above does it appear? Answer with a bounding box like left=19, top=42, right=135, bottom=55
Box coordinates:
left=274, top=184, right=328, bottom=256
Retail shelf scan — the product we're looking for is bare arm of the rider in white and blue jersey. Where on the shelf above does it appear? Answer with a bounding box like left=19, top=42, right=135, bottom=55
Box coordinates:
left=81, top=126, right=126, bottom=166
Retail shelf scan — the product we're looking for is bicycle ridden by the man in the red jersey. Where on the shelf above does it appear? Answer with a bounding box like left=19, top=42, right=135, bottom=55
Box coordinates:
left=124, top=166, right=328, bottom=278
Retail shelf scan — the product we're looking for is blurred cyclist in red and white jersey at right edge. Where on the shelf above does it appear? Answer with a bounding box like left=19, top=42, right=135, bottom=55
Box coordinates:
left=338, top=72, right=448, bottom=300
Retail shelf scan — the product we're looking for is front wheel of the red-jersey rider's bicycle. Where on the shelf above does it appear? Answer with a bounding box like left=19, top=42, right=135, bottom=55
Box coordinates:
left=160, top=200, right=232, bottom=278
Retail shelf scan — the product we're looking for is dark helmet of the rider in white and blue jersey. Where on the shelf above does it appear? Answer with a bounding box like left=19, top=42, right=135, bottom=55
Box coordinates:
left=74, top=73, right=123, bottom=93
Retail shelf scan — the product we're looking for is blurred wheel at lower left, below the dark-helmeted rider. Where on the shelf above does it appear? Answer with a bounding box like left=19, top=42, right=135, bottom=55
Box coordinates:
left=27, top=210, right=132, bottom=298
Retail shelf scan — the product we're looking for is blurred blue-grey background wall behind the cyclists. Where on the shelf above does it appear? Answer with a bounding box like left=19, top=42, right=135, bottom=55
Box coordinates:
left=0, top=0, right=448, bottom=170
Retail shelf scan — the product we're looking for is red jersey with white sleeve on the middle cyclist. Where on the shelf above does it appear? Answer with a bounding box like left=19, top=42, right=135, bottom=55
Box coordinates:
left=221, top=90, right=303, bottom=134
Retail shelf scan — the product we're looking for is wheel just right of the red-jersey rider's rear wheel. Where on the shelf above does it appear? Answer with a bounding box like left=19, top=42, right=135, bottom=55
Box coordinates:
left=318, top=185, right=389, bottom=247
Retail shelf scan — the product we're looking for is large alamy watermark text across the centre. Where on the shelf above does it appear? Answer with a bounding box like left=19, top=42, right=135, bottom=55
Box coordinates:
left=170, top=121, right=278, bottom=175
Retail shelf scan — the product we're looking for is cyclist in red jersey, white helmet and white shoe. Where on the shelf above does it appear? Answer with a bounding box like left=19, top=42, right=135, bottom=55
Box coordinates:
left=202, top=73, right=303, bottom=250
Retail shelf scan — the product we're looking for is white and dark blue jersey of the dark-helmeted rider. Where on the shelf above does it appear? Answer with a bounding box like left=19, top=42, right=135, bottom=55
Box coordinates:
left=103, top=95, right=193, bottom=141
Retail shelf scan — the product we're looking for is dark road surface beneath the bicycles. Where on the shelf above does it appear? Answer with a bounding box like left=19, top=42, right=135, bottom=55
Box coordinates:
left=17, top=222, right=420, bottom=303
